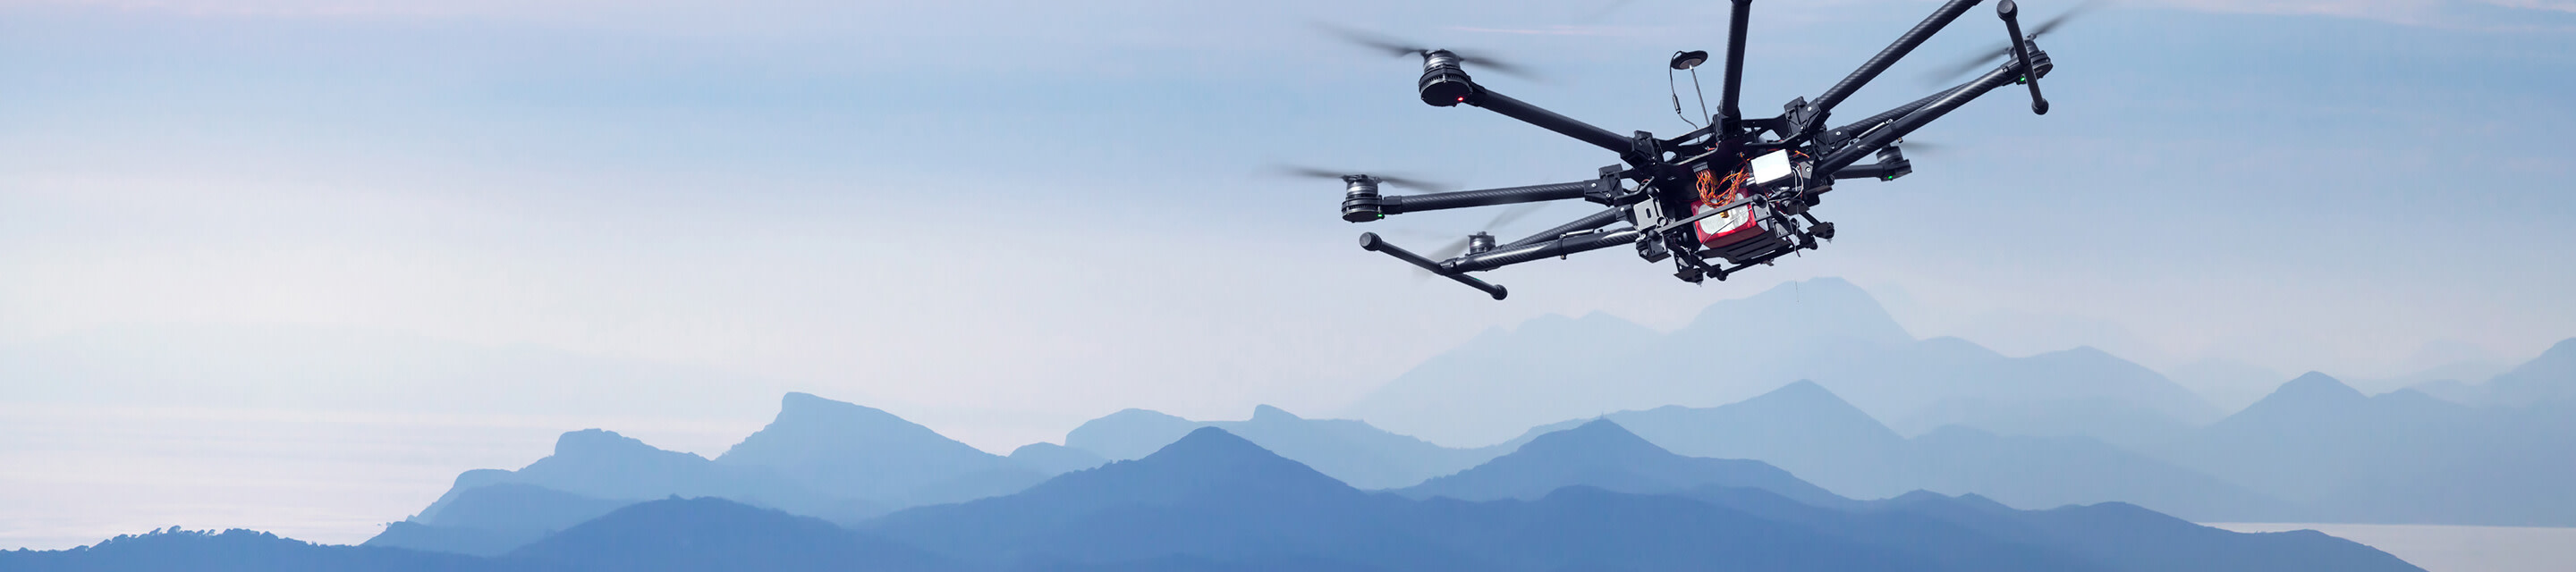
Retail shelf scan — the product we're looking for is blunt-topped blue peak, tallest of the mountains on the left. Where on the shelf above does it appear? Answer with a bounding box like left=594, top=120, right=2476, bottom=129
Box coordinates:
left=716, top=394, right=1046, bottom=508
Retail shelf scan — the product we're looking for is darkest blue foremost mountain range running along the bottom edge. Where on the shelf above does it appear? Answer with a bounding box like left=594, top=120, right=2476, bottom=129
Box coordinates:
left=0, top=423, right=2416, bottom=572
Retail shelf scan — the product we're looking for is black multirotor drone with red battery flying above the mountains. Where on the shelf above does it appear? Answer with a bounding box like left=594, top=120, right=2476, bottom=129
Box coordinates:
left=1335, top=0, right=2063, bottom=299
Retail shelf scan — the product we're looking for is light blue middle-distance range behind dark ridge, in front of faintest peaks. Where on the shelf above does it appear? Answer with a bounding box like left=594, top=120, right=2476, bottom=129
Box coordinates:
left=1066, top=382, right=2310, bottom=520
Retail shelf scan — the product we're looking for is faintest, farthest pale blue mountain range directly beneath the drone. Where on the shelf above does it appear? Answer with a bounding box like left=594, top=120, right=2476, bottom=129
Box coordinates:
left=1342, top=278, right=2221, bottom=446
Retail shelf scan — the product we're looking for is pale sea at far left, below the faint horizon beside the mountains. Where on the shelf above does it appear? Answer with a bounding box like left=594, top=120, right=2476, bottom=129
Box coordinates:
left=0, top=402, right=760, bottom=549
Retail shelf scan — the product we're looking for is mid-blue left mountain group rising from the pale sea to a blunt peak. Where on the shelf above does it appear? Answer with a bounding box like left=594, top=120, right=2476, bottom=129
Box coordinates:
left=366, top=394, right=1051, bottom=554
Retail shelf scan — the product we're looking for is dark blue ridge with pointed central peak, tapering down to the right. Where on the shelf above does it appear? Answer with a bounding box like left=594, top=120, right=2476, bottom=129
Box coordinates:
left=860, top=428, right=2414, bottom=572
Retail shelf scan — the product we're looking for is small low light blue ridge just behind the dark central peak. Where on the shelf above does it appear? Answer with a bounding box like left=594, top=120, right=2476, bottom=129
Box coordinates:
left=1063, top=405, right=1520, bottom=490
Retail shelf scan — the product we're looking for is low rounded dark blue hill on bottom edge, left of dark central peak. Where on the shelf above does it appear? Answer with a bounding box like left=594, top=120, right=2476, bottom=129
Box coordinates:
left=500, top=497, right=955, bottom=572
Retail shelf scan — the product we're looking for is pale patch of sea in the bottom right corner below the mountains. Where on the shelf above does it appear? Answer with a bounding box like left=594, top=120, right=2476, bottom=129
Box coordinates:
left=2207, top=523, right=2576, bottom=572
